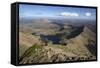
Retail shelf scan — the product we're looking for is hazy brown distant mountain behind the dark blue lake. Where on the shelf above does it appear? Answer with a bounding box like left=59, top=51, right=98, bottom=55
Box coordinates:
left=20, top=18, right=60, bottom=35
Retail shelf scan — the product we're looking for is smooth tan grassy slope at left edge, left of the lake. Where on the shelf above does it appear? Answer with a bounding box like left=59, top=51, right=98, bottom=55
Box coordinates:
left=19, top=32, right=40, bottom=56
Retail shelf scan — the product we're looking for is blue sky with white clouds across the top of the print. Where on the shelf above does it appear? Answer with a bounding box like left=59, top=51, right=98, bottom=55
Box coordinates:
left=19, top=4, right=96, bottom=20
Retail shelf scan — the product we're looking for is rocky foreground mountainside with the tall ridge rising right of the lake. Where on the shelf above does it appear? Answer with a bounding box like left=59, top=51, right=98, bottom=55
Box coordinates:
left=19, top=25, right=96, bottom=64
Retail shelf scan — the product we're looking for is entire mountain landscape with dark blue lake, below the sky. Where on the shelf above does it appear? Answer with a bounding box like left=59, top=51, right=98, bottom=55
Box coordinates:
left=19, top=18, right=96, bottom=64
